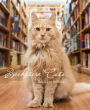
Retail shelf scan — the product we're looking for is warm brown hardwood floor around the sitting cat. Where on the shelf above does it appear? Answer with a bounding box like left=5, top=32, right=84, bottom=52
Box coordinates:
left=0, top=70, right=90, bottom=110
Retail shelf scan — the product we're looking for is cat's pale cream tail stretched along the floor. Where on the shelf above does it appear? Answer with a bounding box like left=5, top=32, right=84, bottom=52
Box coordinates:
left=71, top=83, right=90, bottom=95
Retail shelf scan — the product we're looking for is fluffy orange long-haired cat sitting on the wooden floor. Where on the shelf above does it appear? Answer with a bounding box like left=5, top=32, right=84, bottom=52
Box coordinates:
left=26, top=14, right=90, bottom=107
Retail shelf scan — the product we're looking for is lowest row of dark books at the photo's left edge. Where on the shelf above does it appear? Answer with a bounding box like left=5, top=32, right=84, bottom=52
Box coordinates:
left=0, top=51, right=7, bottom=68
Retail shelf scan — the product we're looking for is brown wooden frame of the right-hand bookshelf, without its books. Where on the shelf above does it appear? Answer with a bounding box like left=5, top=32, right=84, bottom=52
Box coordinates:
left=64, top=0, right=90, bottom=74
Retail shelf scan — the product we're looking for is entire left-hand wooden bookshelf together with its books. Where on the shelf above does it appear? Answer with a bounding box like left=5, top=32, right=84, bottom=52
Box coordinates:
left=0, top=0, right=28, bottom=74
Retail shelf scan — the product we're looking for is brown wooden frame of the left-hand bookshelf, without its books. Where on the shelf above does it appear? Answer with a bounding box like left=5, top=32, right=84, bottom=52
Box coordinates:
left=0, top=0, right=28, bottom=74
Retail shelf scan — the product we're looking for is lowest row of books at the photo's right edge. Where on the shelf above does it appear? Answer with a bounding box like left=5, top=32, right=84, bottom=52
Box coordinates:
left=83, top=52, right=90, bottom=68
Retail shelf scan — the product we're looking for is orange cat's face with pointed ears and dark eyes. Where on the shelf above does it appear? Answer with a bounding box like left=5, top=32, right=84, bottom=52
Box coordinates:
left=31, top=15, right=58, bottom=43
